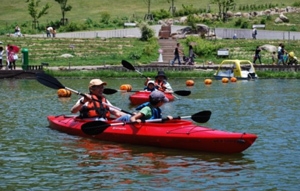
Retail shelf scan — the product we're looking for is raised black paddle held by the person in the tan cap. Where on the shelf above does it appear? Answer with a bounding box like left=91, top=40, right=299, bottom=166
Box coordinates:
left=36, top=73, right=133, bottom=115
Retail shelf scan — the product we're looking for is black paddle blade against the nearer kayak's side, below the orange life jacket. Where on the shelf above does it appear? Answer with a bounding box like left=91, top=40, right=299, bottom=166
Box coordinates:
left=81, top=121, right=110, bottom=135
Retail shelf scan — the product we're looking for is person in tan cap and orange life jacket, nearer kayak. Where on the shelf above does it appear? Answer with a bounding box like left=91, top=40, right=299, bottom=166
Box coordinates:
left=71, top=79, right=125, bottom=120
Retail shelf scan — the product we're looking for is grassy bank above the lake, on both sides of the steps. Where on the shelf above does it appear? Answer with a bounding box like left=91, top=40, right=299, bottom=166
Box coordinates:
left=0, top=37, right=300, bottom=67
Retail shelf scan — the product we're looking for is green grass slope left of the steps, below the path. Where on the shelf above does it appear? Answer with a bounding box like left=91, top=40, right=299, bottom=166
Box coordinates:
left=0, top=37, right=158, bottom=66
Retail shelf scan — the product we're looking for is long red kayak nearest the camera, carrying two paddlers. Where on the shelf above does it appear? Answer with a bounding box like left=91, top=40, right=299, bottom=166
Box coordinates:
left=48, top=115, right=257, bottom=154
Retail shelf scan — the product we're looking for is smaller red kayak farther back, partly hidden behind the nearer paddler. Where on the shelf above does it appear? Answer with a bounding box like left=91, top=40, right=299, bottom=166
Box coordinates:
left=129, top=91, right=175, bottom=105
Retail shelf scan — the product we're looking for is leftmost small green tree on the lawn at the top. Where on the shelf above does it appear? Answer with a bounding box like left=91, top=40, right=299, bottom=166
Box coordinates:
left=26, top=0, right=50, bottom=29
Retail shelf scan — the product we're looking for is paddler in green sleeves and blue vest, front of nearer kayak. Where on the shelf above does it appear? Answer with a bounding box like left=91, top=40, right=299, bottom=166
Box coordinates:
left=115, top=91, right=173, bottom=123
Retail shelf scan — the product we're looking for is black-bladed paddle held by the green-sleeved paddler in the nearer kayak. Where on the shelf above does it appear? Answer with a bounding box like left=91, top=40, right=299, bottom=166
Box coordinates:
left=81, top=110, right=211, bottom=135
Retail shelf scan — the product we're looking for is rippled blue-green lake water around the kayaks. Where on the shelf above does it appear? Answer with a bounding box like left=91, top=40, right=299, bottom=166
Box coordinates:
left=0, top=78, right=300, bottom=191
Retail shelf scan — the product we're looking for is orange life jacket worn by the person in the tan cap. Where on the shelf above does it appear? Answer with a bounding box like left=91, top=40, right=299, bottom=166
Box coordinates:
left=80, top=95, right=110, bottom=119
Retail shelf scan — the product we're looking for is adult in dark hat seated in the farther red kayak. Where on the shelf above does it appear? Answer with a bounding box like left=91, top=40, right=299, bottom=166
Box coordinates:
left=145, top=71, right=173, bottom=93
